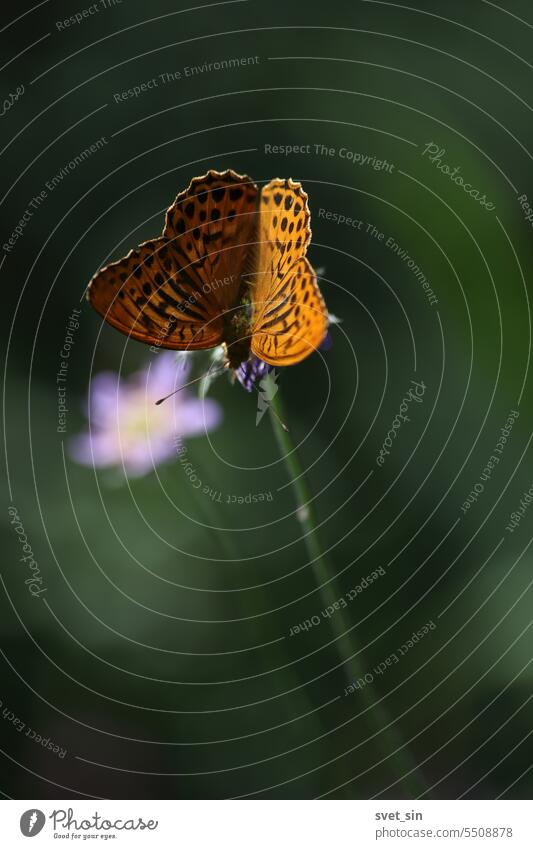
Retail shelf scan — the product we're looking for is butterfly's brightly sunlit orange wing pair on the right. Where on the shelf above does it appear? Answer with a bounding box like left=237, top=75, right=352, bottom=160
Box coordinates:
left=251, top=179, right=328, bottom=365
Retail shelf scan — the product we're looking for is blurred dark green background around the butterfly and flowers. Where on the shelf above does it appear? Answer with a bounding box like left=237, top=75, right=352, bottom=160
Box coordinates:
left=0, top=0, right=533, bottom=799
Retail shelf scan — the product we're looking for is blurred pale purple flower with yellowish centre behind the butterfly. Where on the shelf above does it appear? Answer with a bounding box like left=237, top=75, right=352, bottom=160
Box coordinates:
left=69, top=351, right=222, bottom=477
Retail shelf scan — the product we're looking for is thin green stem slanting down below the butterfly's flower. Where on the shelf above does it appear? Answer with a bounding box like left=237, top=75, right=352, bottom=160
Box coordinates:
left=270, top=392, right=427, bottom=798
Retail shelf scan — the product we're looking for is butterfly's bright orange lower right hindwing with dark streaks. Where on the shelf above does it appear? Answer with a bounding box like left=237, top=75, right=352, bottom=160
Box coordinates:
left=252, top=257, right=328, bottom=366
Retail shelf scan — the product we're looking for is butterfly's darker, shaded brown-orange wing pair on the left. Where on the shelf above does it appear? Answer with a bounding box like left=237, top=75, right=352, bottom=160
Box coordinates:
left=88, top=170, right=258, bottom=350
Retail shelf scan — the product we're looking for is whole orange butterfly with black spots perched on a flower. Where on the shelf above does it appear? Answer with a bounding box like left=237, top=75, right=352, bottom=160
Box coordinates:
left=88, top=170, right=328, bottom=369
